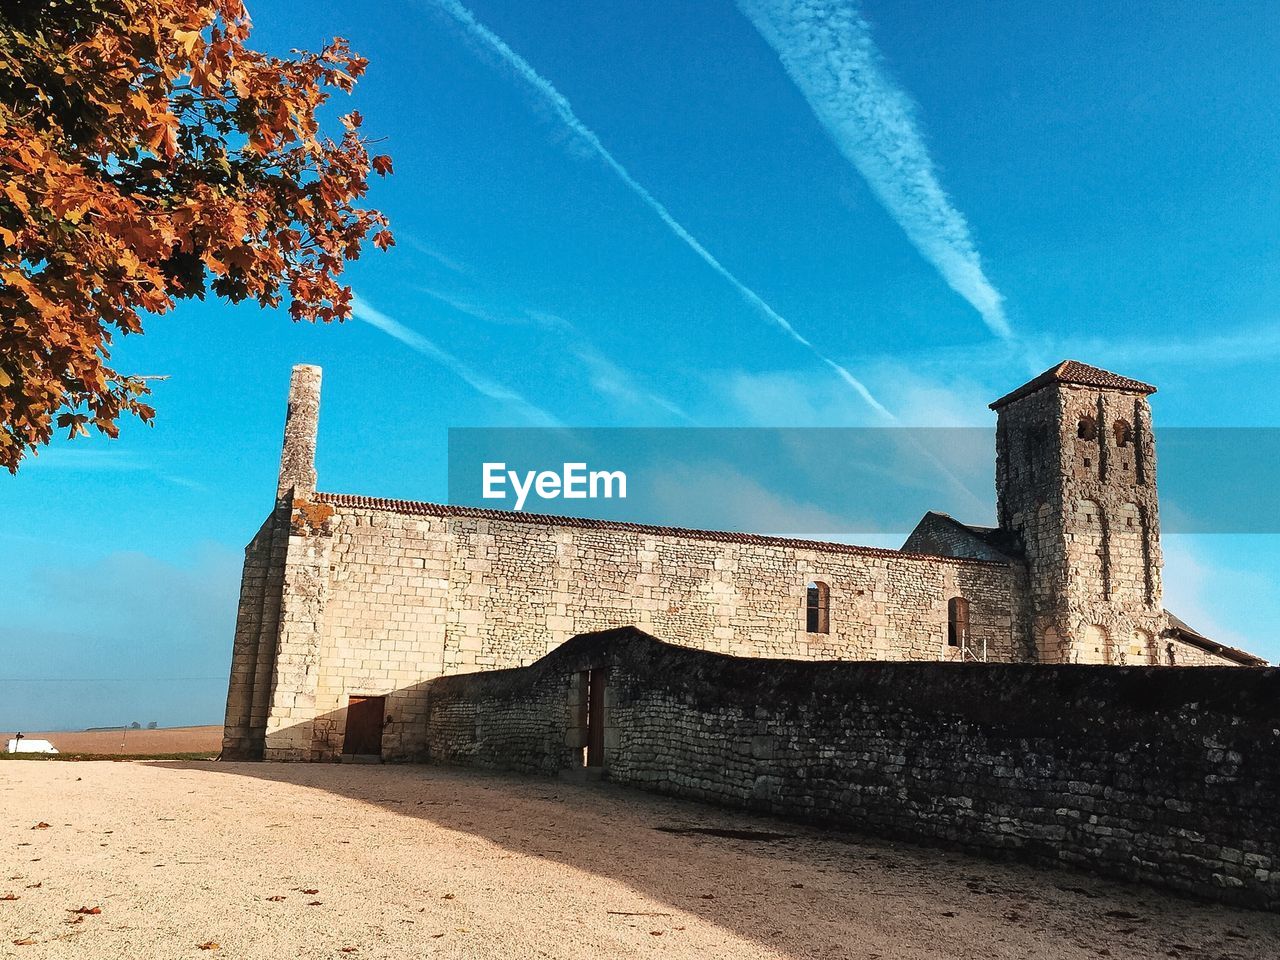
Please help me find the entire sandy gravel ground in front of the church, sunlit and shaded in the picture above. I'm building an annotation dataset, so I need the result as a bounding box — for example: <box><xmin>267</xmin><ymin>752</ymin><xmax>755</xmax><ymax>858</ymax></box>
<box><xmin>0</xmin><ymin>762</ymin><xmax>1280</xmax><ymax>960</ymax></box>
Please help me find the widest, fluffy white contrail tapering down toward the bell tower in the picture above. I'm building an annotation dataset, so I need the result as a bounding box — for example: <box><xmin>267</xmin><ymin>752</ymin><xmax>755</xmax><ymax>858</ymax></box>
<box><xmin>737</xmin><ymin>0</ymin><xmax>1014</xmax><ymax>339</ymax></box>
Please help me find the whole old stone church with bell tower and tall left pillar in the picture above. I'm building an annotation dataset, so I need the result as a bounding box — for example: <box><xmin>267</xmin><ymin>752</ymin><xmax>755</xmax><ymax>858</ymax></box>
<box><xmin>223</xmin><ymin>360</ymin><xmax>1265</xmax><ymax>760</ymax></box>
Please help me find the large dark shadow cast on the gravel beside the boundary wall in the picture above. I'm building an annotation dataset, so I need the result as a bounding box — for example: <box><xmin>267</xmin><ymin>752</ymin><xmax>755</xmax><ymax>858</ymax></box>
<box><xmin>155</xmin><ymin>763</ymin><xmax>1280</xmax><ymax>960</ymax></box>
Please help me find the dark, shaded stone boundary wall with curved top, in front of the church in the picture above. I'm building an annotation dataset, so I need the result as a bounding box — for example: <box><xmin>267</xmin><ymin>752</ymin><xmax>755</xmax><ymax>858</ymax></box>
<box><xmin>424</xmin><ymin>630</ymin><xmax>1280</xmax><ymax>910</ymax></box>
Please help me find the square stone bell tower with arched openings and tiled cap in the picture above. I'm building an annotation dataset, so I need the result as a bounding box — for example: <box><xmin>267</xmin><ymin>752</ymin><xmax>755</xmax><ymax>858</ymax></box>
<box><xmin>991</xmin><ymin>360</ymin><xmax>1166</xmax><ymax>664</ymax></box>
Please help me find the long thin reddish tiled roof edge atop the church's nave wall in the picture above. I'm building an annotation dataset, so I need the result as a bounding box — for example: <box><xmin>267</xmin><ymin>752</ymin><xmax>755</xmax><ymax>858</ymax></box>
<box><xmin>315</xmin><ymin>493</ymin><xmax>1005</xmax><ymax>566</ymax></box>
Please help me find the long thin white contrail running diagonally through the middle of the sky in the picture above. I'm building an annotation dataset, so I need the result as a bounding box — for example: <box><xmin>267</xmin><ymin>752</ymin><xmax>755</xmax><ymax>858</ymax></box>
<box><xmin>430</xmin><ymin>0</ymin><xmax>896</xmax><ymax>421</ymax></box>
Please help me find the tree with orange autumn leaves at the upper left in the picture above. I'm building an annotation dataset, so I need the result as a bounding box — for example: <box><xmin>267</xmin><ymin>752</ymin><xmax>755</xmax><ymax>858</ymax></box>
<box><xmin>0</xmin><ymin>0</ymin><xmax>392</xmax><ymax>471</ymax></box>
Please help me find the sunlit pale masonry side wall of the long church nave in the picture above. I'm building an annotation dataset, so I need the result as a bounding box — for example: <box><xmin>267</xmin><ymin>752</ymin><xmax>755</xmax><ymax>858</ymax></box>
<box><xmin>293</xmin><ymin>494</ymin><xmax>1015</xmax><ymax>759</ymax></box>
